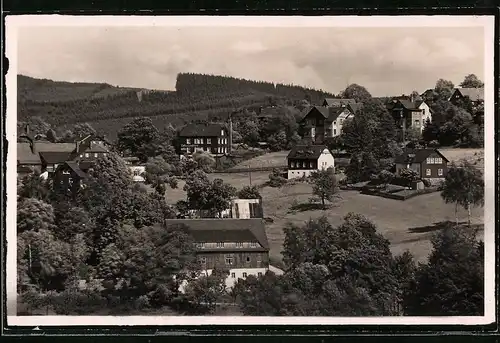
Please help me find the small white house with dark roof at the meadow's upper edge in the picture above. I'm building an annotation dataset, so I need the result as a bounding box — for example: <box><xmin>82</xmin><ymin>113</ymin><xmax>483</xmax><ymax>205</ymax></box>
<box><xmin>287</xmin><ymin>145</ymin><xmax>335</xmax><ymax>179</ymax></box>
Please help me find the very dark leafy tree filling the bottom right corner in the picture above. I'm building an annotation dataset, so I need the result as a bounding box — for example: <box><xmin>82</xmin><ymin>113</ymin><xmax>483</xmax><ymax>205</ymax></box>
<box><xmin>405</xmin><ymin>225</ymin><xmax>484</xmax><ymax>316</ymax></box>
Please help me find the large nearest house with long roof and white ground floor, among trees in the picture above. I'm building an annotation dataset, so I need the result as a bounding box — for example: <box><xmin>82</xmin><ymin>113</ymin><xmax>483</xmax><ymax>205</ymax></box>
<box><xmin>165</xmin><ymin>219</ymin><xmax>270</xmax><ymax>288</ymax></box>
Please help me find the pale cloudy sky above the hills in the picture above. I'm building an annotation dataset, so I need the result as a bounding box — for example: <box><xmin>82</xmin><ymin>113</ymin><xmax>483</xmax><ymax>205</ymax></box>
<box><xmin>18</xmin><ymin>26</ymin><xmax>484</xmax><ymax>96</ymax></box>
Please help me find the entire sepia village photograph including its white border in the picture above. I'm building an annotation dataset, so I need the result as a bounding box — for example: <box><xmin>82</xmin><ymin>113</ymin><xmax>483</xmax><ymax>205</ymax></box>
<box><xmin>5</xmin><ymin>15</ymin><xmax>498</xmax><ymax>325</ymax></box>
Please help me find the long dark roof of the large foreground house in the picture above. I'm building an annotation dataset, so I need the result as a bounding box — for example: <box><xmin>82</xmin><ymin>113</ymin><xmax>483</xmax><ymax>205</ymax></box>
<box><xmin>166</xmin><ymin>219</ymin><xmax>269</xmax><ymax>250</ymax></box>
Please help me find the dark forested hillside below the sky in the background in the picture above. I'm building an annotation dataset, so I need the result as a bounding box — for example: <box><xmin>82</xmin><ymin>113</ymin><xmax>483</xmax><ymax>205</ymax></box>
<box><xmin>18</xmin><ymin>74</ymin><xmax>333</xmax><ymax>138</ymax></box>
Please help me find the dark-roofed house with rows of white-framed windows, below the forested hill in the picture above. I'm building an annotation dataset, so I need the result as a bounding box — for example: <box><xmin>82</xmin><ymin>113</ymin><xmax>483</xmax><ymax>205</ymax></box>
<box><xmin>177</xmin><ymin>123</ymin><xmax>231</xmax><ymax>156</ymax></box>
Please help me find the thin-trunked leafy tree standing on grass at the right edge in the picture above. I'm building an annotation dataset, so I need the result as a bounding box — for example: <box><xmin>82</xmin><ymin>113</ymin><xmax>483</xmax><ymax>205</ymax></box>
<box><xmin>441</xmin><ymin>160</ymin><xmax>484</xmax><ymax>226</ymax></box>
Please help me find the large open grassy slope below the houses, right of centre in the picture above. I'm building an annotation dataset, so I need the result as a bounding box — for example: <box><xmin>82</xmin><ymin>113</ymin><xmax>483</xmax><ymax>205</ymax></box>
<box><xmin>261</xmin><ymin>183</ymin><xmax>484</xmax><ymax>261</ymax></box>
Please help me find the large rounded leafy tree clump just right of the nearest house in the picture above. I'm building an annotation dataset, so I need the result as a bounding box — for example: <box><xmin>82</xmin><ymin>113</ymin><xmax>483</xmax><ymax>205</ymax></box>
<box><xmin>234</xmin><ymin>213</ymin><xmax>412</xmax><ymax>316</ymax></box>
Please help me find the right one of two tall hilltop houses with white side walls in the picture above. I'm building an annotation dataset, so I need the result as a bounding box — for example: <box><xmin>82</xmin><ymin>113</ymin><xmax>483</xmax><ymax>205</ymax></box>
<box><xmin>387</xmin><ymin>99</ymin><xmax>432</xmax><ymax>132</ymax></box>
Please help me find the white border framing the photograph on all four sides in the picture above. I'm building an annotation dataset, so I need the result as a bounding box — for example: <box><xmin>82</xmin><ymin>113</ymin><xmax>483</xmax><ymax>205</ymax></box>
<box><xmin>5</xmin><ymin>15</ymin><xmax>497</xmax><ymax>327</ymax></box>
